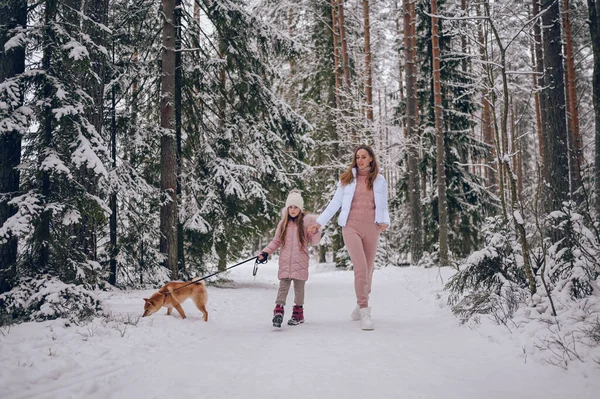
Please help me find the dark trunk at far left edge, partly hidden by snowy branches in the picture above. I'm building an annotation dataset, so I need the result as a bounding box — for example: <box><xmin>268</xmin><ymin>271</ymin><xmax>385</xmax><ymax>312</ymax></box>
<box><xmin>0</xmin><ymin>0</ymin><xmax>27</xmax><ymax>294</ymax></box>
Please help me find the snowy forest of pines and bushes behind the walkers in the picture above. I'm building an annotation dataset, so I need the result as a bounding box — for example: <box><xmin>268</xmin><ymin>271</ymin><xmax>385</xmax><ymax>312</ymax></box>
<box><xmin>0</xmin><ymin>0</ymin><xmax>600</xmax><ymax>356</ymax></box>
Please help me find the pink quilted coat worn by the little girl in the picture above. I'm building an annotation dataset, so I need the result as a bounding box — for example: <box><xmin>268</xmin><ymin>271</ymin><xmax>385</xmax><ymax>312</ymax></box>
<box><xmin>261</xmin><ymin>210</ymin><xmax>321</xmax><ymax>280</ymax></box>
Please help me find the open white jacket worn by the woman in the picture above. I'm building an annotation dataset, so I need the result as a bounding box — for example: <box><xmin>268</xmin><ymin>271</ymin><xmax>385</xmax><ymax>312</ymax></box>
<box><xmin>317</xmin><ymin>168</ymin><xmax>390</xmax><ymax>227</ymax></box>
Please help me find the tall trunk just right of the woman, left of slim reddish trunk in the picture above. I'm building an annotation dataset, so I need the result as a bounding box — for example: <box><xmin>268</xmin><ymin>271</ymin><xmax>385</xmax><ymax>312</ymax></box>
<box><xmin>404</xmin><ymin>0</ymin><xmax>423</xmax><ymax>264</ymax></box>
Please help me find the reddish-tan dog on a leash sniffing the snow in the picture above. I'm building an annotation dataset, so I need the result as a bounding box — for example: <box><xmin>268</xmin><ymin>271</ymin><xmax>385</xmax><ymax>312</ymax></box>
<box><xmin>142</xmin><ymin>277</ymin><xmax>208</xmax><ymax>321</ymax></box>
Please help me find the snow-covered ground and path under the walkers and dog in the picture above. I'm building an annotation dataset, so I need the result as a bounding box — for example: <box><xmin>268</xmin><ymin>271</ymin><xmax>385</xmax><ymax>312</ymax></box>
<box><xmin>0</xmin><ymin>260</ymin><xmax>600</xmax><ymax>399</ymax></box>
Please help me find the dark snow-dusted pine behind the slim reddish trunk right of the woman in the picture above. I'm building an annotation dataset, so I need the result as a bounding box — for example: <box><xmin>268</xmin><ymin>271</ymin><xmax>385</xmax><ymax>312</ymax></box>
<box><xmin>417</xmin><ymin>2</ymin><xmax>497</xmax><ymax>256</ymax></box>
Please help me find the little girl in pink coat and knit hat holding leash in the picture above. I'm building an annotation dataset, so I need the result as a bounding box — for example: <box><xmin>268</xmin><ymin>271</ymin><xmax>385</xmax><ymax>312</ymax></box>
<box><xmin>258</xmin><ymin>189</ymin><xmax>321</xmax><ymax>327</ymax></box>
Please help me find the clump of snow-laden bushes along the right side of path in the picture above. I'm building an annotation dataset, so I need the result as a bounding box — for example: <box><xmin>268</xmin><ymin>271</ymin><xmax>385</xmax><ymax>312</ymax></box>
<box><xmin>446</xmin><ymin>203</ymin><xmax>600</xmax><ymax>368</ymax></box>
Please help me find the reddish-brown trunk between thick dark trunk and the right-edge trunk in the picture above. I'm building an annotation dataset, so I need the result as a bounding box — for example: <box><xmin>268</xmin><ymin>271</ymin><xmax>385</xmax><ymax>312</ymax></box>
<box><xmin>562</xmin><ymin>0</ymin><xmax>583</xmax><ymax>202</ymax></box>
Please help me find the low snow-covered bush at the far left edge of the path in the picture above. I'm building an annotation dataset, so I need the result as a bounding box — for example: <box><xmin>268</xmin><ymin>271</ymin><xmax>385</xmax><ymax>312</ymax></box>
<box><xmin>0</xmin><ymin>275</ymin><xmax>103</xmax><ymax>324</ymax></box>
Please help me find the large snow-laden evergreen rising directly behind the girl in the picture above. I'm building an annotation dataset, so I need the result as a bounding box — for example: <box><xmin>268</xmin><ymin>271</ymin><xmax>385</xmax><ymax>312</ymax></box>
<box><xmin>181</xmin><ymin>1</ymin><xmax>308</xmax><ymax>269</ymax></box>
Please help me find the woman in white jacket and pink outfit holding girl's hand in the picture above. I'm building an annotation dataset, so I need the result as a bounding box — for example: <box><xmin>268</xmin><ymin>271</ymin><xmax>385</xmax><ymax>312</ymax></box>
<box><xmin>310</xmin><ymin>145</ymin><xmax>390</xmax><ymax>330</ymax></box>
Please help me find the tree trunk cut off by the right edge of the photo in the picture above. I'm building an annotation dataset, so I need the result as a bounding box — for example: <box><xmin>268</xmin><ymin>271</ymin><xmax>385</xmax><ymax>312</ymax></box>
<box><xmin>588</xmin><ymin>0</ymin><xmax>600</xmax><ymax>220</ymax></box>
